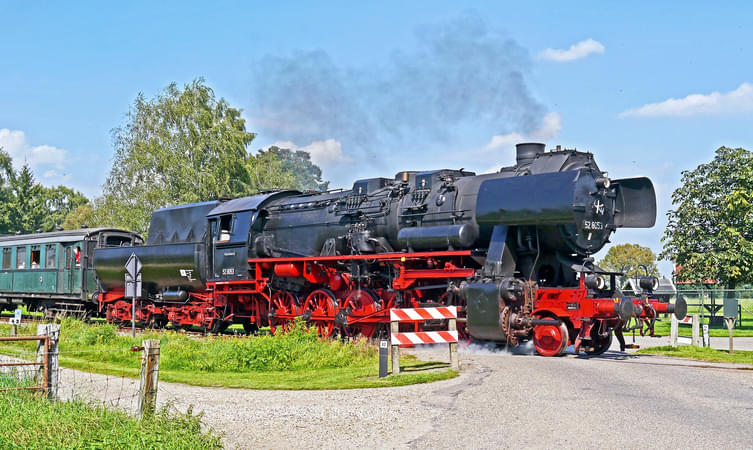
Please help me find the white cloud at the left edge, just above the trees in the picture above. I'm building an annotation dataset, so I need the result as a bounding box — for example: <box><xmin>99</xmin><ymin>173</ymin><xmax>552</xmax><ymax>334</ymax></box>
<box><xmin>0</xmin><ymin>128</ymin><xmax>68</xmax><ymax>176</ymax></box>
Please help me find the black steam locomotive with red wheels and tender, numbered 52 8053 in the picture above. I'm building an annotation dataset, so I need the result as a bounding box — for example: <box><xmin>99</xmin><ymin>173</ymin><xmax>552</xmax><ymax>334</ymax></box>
<box><xmin>94</xmin><ymin>143</ymin><xmax>686</xmax><ymax>356</ymax></box>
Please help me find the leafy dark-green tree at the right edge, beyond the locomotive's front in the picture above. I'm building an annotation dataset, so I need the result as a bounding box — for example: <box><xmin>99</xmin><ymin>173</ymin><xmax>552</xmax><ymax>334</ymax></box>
<box><xmin>660</xmin><ymin>147</ymin><xmax>753</xmax><ymax>289</ymax></box>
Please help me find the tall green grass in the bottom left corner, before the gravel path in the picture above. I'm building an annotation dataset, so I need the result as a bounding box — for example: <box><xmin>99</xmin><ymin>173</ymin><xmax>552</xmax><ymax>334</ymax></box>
<box><xmin>0</xmin><ymin>377</ymin><xmax>222</xmax><ymax>449</ymax></box>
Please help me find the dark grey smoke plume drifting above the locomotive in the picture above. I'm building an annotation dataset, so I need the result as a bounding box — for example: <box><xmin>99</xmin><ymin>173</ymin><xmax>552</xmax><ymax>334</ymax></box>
<box><xmin>247</xmin><ymin>17</ymin><xmax>546</xmax><ymax>180</ymax></box>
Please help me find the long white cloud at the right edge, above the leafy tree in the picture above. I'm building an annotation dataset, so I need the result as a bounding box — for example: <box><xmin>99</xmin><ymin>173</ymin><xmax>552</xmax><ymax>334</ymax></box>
<box><xmin>619</xmin><ymin>83</ymin><xmax>753</xmax><ymax>117</ymax></box>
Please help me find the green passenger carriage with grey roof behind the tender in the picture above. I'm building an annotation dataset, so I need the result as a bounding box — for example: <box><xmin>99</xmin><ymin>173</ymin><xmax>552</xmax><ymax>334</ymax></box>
<box><xmin>0</xmin><ymin>228</ymin><xmax>143</xmax><ymax>317</ymax></box>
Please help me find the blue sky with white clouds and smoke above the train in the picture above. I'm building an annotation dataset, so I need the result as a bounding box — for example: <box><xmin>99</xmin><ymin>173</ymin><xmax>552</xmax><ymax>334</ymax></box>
<box><xmin>0</xmin><ymin>1</ymin><xmax>753</xmax><ymax>273</ymax></box>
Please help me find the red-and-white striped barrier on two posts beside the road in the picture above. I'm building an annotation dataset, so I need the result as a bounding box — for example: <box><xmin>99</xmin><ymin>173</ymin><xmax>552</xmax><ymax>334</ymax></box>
<box><xmin>390</xmin><ymin>306</ymin><xmax>460</xmax><ymax>375</ymax></box>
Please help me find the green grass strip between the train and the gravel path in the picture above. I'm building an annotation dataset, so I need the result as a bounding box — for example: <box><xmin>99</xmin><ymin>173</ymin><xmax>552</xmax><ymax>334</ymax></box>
<box><xmin>0</xmin><ymin>319</ymin><xmax>457</xmax><ymax>389</ymax></box>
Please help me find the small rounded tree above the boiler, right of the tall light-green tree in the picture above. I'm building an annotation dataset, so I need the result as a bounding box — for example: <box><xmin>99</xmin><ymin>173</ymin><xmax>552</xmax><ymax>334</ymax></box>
<box><xmin>248</xmin><ymin>146</ymin><xmax>329</xmax><ymax>191</ymax></box>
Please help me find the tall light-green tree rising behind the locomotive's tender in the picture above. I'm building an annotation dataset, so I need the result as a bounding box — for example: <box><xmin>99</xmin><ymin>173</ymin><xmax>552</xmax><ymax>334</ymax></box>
<box><xmin>97</xmin><ymin>79</ymin><xmax>254</xmax><ymax>233</ymax></box>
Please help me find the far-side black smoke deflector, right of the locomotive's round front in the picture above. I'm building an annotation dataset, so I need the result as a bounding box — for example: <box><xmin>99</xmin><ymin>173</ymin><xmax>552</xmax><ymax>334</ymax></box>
<box><xmin>612</xmin><ymin>177</ymin><xmax>656</xmax><ymax>228</ymax></box>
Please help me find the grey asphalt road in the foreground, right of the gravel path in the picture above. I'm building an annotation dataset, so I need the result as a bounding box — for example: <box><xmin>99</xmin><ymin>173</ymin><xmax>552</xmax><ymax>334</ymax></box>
<box><xmin>405</xmin><ymin>351</ymin><xmax>753</xmax><ymax>448</ymax></box>
